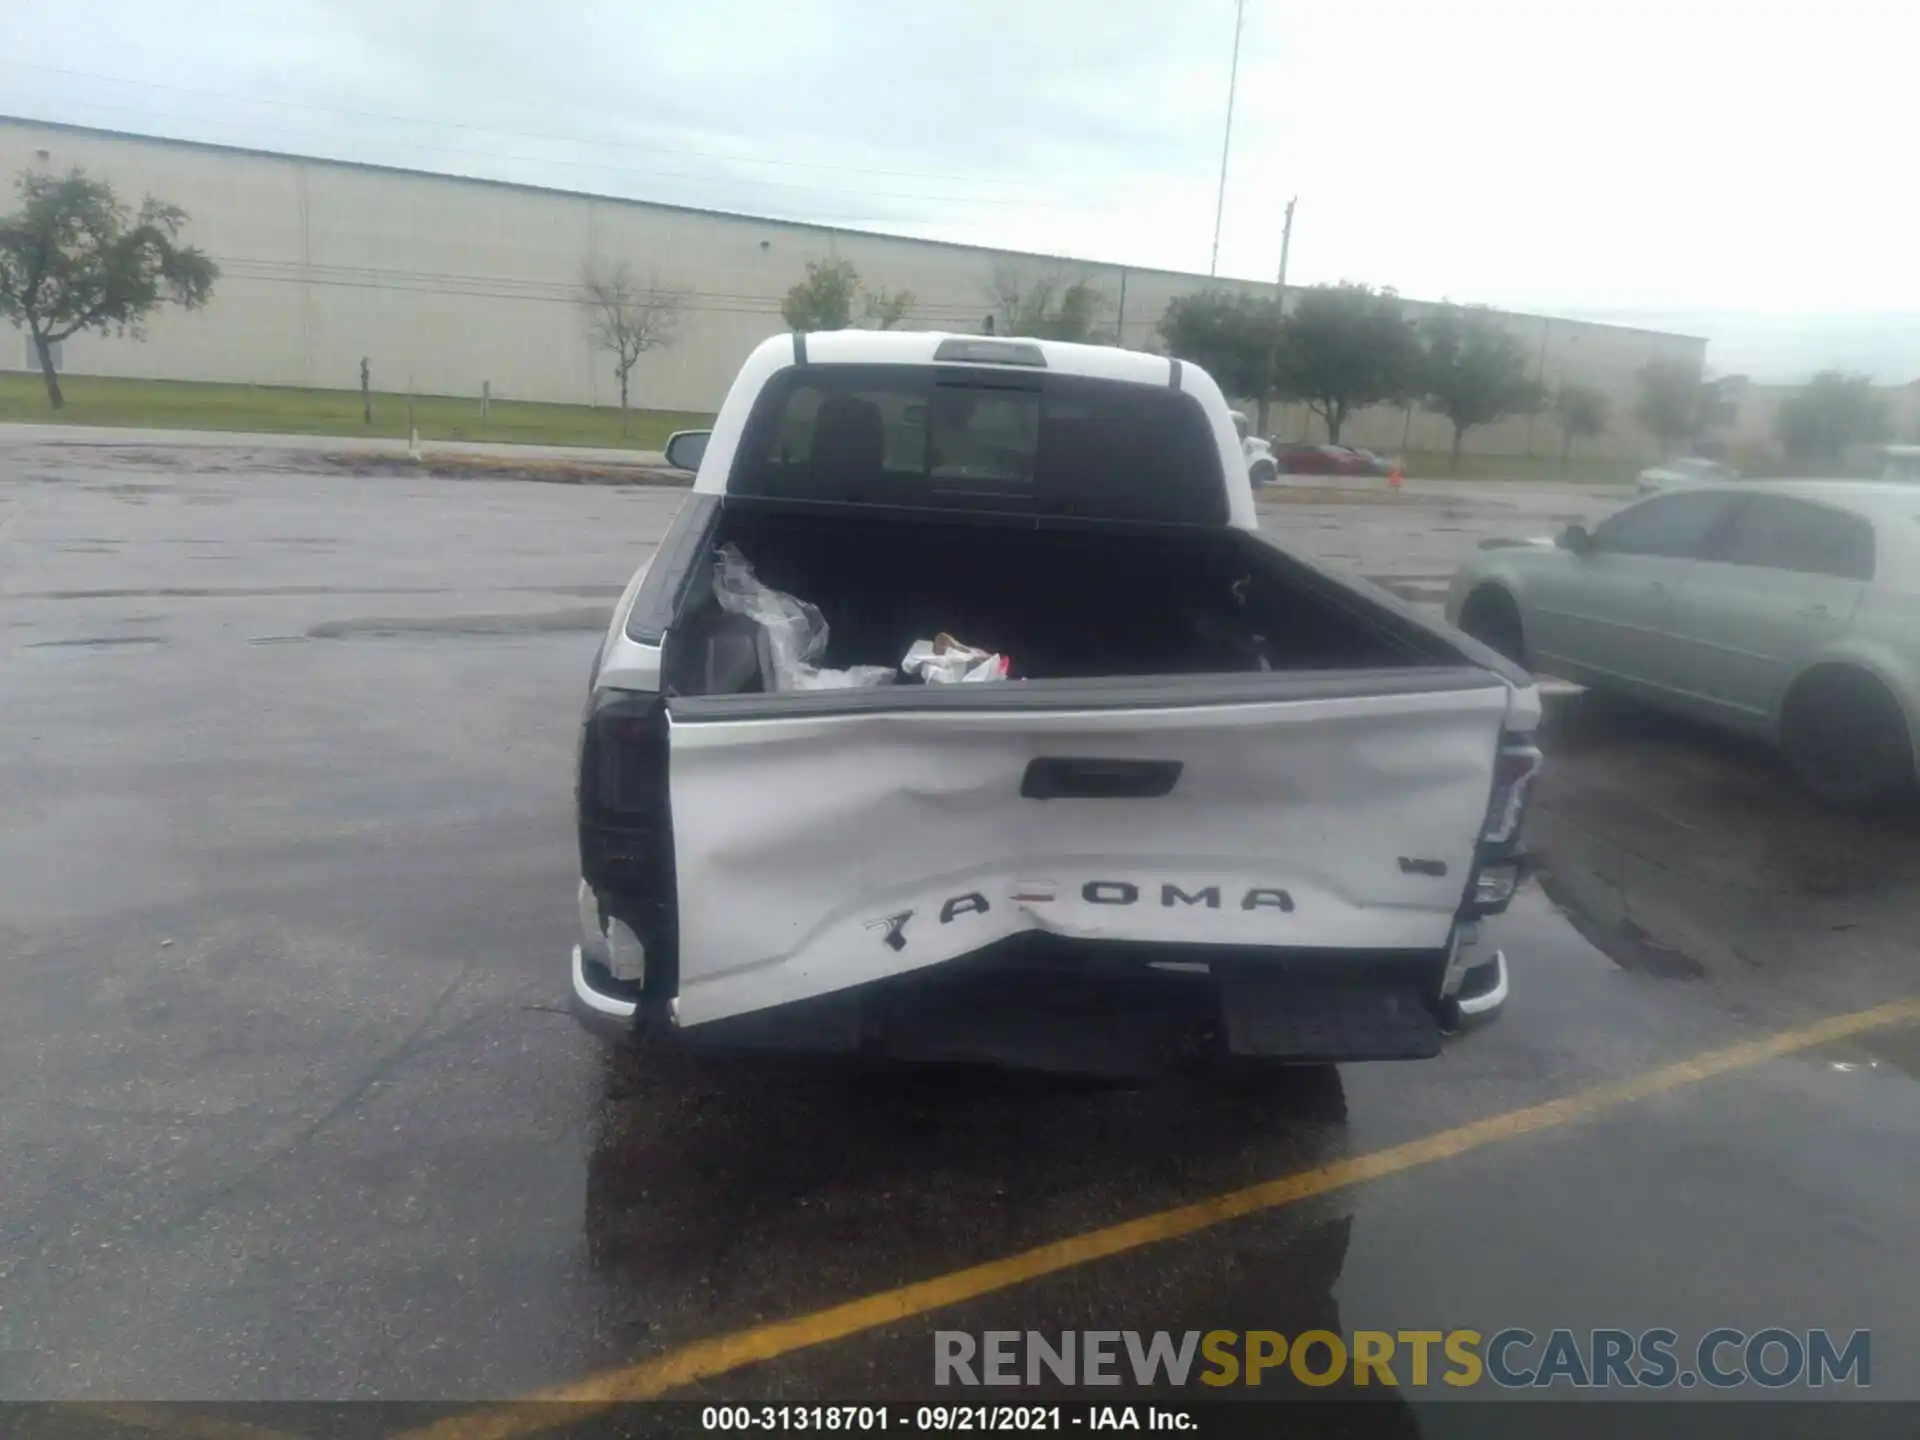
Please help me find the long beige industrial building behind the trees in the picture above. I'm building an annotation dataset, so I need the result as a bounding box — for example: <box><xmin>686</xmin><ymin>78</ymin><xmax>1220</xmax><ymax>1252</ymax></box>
<box><xmin>0</xmin><ymin>119</ymin><xmax>1707</xmax><ymax>455</ymax></box>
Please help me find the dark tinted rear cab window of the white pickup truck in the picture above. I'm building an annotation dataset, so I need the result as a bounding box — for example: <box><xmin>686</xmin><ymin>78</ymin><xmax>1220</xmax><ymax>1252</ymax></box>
<box><xmin>728</xmin><ymin>365</ymin><xmax>1227</xmax><ymax>526</ymax></box>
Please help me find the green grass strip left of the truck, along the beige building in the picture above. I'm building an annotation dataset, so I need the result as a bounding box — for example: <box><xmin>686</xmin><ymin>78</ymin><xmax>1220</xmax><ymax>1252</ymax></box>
<box><xmin>0</xmin><ymin>372</ymin><xmax>712</xmax><ymax>449</ymax></box>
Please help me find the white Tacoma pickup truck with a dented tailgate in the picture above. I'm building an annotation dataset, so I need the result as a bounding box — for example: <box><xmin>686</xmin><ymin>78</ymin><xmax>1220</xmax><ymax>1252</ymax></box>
<box><xmin>572</xmin><ymin>330</ymin><xmax>1540</xmax><ymax>1071</ymax></box>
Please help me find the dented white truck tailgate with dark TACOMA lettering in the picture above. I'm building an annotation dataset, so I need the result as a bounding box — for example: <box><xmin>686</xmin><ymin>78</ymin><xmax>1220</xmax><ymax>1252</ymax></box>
<box><xmin>670</xmin><ymin>684</ymin><xmax>1511</xmax><ymax>1025</ymax></box>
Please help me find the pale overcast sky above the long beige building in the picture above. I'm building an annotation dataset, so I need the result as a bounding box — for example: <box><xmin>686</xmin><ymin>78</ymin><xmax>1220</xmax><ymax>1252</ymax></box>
<box><xmin>0</xmin><ymin>0</ymin><xmax>1920</xmax><ymax>382</ymax></box>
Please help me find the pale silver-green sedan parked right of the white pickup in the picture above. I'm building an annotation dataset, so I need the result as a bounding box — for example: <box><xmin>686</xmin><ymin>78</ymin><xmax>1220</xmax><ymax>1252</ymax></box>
<box><xmin>1448</xmin><ymin>480</ymin><xmax>1920</xmax><ymax>804</ymax></box>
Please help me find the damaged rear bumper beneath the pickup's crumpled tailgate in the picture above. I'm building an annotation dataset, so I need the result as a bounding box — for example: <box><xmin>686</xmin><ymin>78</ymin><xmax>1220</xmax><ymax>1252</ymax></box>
<box><xmin>570</xmin><ymin>929</ymin><xmax>1509</xmax><ymax>1075</ymax></box>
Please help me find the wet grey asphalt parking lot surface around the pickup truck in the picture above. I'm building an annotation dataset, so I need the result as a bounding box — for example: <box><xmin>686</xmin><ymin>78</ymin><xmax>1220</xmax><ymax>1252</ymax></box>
<box><xmin>0</xmin><ymin>440</ymin><xmax>1920</xmax><ymax>1434</ymax></box>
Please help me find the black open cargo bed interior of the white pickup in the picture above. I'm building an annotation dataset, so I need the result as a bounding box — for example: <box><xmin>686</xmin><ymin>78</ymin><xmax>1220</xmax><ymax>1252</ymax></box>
<box><xmin>666</xmin><ymin>505</ymin><xmax>1461</xmax><ymax>695</ymax></box>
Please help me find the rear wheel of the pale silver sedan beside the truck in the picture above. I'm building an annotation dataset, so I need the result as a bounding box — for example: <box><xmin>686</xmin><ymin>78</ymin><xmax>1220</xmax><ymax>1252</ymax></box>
<box><xmin>1780</xmin><ymin>666</ymin><xmax>1914</xmax><ymax>808</ymax></box>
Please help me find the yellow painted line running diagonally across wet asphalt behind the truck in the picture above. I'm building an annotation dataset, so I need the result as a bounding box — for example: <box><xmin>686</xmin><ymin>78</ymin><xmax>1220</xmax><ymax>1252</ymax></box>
<box><xmin>405</xmin><ymin>998</ymin><xmax>1920</xmax><ymax>1440</ymax></box>
